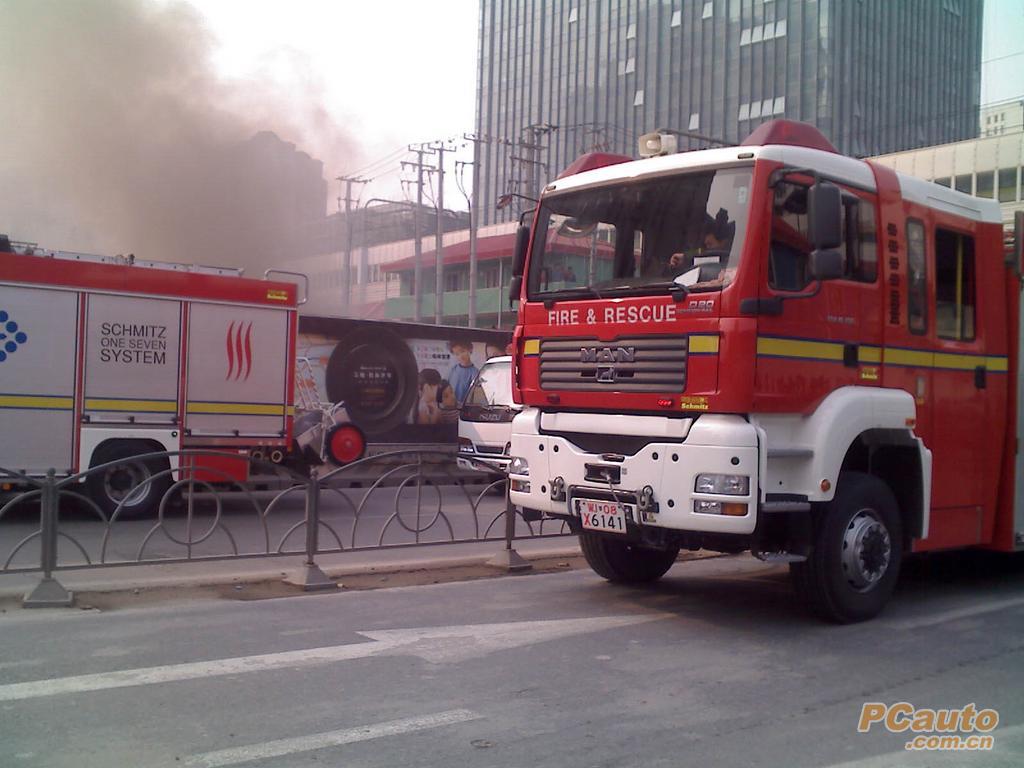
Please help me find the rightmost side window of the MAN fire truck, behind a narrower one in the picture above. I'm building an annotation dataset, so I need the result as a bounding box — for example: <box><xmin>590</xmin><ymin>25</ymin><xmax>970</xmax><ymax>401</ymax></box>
<box><xmin>935</xmin><ymin>229</ymin><xmax>975</xmax><ymax>341</ymax></box>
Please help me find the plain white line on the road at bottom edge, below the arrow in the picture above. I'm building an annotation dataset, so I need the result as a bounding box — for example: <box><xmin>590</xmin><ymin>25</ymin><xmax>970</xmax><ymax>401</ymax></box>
<box><xmin>183</xmin><ymin>710</ymin><xmax>481</xmax><ymax>768</ymax></box>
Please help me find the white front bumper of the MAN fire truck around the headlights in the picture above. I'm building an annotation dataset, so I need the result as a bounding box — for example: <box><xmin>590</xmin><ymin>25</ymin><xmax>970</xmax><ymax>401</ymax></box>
<box><xmin>509</xmin><ymin>409</ymin><xmax>759</xmax><ymax>535</ymax></box>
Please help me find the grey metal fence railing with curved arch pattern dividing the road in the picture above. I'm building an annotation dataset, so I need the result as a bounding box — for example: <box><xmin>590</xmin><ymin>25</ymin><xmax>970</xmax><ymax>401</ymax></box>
<box><xmin>0</xmin><ymin>450</ymin><xmax>568</xmax><ymax>605</ymax></box>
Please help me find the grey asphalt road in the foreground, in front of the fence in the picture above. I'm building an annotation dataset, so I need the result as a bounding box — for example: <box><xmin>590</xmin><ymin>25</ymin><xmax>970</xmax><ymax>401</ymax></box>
<box><xmin>0</xmin><ymin>557</ymin><xmax>1024</xmax><ymax>768</ymax></box>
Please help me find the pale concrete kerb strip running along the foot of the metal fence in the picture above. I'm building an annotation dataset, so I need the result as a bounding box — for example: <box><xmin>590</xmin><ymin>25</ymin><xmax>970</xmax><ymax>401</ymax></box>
<box><xmin>0</xmin><ymin>536</ymin><xmax>581</xmax><ymax>601</ymax></box>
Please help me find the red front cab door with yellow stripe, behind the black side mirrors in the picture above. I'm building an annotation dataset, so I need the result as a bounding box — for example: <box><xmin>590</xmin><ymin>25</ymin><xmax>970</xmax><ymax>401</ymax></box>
<box><xmin>755</xmin><ymin>180</ymin><xmax>882</xmax><ymax>413</ymax></box>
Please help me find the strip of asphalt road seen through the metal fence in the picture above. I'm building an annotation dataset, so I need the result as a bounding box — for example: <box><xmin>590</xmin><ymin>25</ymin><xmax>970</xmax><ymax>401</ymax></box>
<box><xmin>0</xmin><ymin>484</ymin><xmax>560</xmax><ymax>568</ymax></box>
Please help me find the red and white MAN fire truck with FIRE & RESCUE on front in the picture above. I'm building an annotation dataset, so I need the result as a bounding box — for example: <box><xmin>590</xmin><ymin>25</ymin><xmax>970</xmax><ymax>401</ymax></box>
<box><xmin>510</xmin><ymin>121</ymin><xmax>1024</xmax><ymax>622</ymax></box>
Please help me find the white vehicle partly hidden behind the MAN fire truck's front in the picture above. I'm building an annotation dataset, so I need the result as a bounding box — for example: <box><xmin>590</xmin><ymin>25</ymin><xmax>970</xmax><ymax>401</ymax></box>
<box><xmin>458</xmin><ymin>356</ymin><xmax>522</xmax><ymax>473</ymax></box>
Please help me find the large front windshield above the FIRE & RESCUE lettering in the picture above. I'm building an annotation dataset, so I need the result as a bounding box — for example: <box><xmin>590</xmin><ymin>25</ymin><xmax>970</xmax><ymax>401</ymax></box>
<box><xmin>527</xmin><ymin>168</ymin><xmax>751</xmax><ymax>299</ymax></box>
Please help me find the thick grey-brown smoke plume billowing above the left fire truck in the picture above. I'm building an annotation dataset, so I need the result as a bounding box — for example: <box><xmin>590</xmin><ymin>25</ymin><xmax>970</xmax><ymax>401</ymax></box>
<box><xmin>0</xmin><ymin>0</ymin><xmax>351</xmax><ymax>268</ymax></box>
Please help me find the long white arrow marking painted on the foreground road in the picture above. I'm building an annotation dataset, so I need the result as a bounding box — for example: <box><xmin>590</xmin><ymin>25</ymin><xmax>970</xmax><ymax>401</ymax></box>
<box><xmin>0</xmin><ymin>613</ymin><xmax>666</xmax><ymax>701</ymax></box>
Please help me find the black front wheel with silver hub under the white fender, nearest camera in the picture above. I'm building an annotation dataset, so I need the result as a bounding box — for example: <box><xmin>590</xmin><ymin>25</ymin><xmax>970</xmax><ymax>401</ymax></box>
<box><xmin>790</xmin><ymin>472</ymin><xmax>903</xmax><ymax>624</ymax></box>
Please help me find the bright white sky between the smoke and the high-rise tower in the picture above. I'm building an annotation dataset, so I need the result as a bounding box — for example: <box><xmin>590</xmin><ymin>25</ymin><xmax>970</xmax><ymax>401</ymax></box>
<box><xmin>187</xmin><ymin>0</ymin><xmax>479</xmax><ymax>210</ymax></box>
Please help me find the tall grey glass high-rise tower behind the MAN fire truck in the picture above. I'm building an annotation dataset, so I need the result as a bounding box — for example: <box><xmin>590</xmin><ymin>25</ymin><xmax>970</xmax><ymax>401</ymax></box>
<box><xmin>476</xmin><ymin>0</ymin><xmax>983</xmax><ymax>222</ymax></box>
